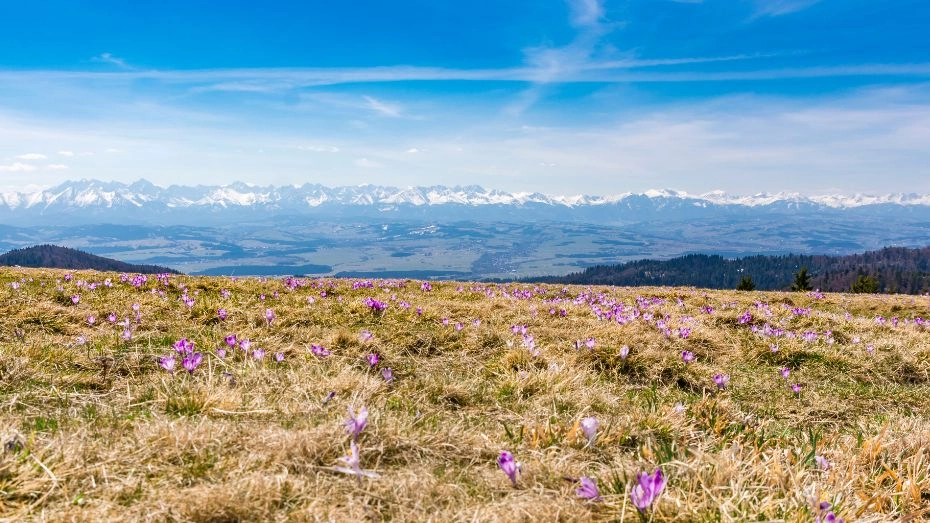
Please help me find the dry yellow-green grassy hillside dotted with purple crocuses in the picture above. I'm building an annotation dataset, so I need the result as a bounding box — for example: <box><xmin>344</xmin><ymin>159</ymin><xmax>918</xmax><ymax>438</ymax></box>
<box><xmin>0</xmin><ymin>269</ymin><xmax>930</xmax><ymax>522</ymax></box>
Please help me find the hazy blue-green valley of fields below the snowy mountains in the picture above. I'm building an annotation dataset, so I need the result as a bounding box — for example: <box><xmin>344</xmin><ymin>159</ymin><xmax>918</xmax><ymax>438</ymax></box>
<box><xmin>0</xmin><ymin>214</ymin><xmax>930</xmax><ymax>280</ymax></box>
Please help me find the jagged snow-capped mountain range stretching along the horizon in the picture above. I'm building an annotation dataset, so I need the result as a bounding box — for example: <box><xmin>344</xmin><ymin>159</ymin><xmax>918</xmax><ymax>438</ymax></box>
<box><xmin>0</xmin><ymin>180</ymin><xmax>930</xmax><ymax>216</ymax></box>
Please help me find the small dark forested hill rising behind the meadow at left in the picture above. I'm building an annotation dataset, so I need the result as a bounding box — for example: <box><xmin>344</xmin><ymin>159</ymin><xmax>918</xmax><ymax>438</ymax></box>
<box><xmin>0</xmin><ymin>245</ymin><xmax>178</xmax><ymax>274</ymax></box>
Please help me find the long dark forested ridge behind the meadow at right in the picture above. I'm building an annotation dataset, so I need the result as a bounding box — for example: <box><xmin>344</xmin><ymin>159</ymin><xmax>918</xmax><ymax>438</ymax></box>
<box><xmin>532</xmin><ymin>247</ymin><xmax>930</xmax><ymax>294</ymax></box>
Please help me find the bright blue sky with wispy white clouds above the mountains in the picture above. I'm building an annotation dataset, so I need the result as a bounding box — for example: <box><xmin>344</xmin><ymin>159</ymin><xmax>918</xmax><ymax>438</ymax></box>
<box><xmin>0</xmin><ymin>0</ymin><xmax>930</xmax><ymax>195</ymax></box>
